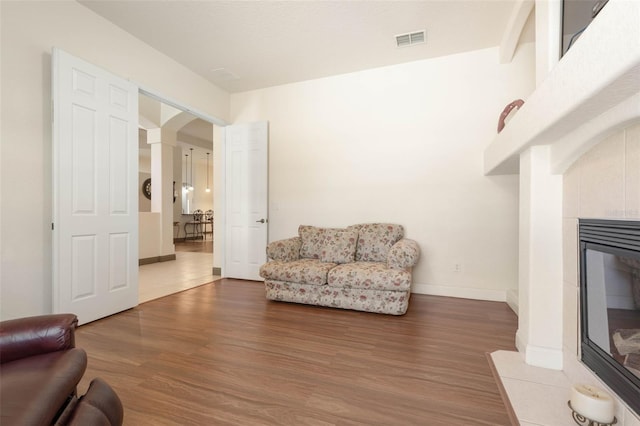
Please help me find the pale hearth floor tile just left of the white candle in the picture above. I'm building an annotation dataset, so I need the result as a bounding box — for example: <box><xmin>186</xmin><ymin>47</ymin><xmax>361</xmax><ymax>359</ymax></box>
<box><xmin>502</xmin><ymin>378</ymin><xmax>575</xmax><ymax>426</ymax></box>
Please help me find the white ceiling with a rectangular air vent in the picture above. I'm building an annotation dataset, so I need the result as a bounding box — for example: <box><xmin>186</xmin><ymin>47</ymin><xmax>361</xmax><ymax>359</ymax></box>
<box><xmin>78</xmin><ymin>0</ymin><xmax>533</xmax><ymax>93</ymax></box>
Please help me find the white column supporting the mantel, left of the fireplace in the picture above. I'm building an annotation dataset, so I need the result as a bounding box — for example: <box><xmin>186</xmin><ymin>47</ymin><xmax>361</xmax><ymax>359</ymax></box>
<box><xmin>516</xmin><ymin>146</ymin><xmax>563</xmax><ymax>370</ymax></box>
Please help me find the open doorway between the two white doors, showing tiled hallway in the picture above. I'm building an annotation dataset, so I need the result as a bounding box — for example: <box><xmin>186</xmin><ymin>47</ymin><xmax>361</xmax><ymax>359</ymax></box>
<box><xmin>138</xmin><ymin>91</ymin><xmax>220</xmax><ymax>303</ymax></box>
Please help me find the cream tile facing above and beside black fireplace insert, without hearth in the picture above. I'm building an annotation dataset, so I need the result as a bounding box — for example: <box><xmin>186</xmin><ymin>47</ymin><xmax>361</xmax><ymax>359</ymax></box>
<box><xmin>562</xmin><ymin>124</ymin><xmax>640</xmax><ymax>425</ymax></box>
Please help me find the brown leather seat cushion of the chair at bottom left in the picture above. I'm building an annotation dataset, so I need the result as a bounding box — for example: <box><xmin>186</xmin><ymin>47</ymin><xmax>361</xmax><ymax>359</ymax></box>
<box><xmin>0</xmin><ymin>348</ymin><xmax>87</xmax><ymax>425</ymax></box>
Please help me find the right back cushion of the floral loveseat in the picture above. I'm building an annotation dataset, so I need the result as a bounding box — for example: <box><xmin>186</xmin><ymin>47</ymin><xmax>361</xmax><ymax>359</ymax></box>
<box><xmin>347</xmin><ymin>223</ymin><xmax>404</xmax><ymax>262</ymax></box>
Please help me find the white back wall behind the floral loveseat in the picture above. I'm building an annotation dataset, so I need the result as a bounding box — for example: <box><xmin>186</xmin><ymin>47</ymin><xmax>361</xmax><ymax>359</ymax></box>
<box><xmin>231</xmin><ymin>45</ymin><xmax>535</xmax><ymax>300</ymax></box>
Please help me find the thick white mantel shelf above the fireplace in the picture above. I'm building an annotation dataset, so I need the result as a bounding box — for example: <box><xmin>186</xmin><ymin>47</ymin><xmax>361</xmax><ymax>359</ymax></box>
<box><xmin>484</xmin><ymin>0</ymin><xmax>640</xmax><ymax>175</ymax></box>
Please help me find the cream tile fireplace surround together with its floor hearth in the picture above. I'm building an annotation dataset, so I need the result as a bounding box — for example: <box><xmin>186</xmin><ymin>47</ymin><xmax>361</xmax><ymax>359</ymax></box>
<box><xmin>492</xmin><ymin>125</ymin><xmax>640</xmax><ymax>426</ymax></box>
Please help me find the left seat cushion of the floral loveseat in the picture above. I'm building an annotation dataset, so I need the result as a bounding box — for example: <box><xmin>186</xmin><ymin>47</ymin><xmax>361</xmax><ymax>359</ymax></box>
<box><xmin>260</xmin><ymin>259</ymin><xmax>336</xmax><ymax>285</ymax></box>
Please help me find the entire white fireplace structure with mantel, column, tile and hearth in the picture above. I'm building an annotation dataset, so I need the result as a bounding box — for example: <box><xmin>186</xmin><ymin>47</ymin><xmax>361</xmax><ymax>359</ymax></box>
<box><xmin>485</xmin><ymin>0</ymin><xmax>640</xmax><ymax>426</ymax></box>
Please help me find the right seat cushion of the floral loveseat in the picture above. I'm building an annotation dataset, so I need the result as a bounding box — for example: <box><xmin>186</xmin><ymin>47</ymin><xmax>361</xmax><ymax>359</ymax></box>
<box><xmin>327</xmin><ymin>262</ymin><xmax>411</xmax><ymax>291</ymax></box>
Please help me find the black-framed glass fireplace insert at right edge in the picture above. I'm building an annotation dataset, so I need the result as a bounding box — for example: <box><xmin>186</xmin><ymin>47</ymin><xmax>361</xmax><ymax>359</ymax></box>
<box><xmin>578</xmin><ymin>219</ymin><xmax>640</xmax><ymax>413</ymax></box>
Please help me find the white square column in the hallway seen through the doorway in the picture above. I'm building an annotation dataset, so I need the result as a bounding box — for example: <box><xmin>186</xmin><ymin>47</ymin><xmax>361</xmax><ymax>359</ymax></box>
<box><xmin>147</xmin><ymin>129</ymin><xmax>175</xmax><ymax>256</ymax></box>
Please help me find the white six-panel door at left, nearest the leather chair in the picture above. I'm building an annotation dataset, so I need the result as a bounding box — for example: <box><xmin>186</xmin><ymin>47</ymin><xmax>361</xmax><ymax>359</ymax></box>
<box><xmin>52</xmin><ymin>49</ymin><xmax>138</xmax><ymax>323</ymax></box>
